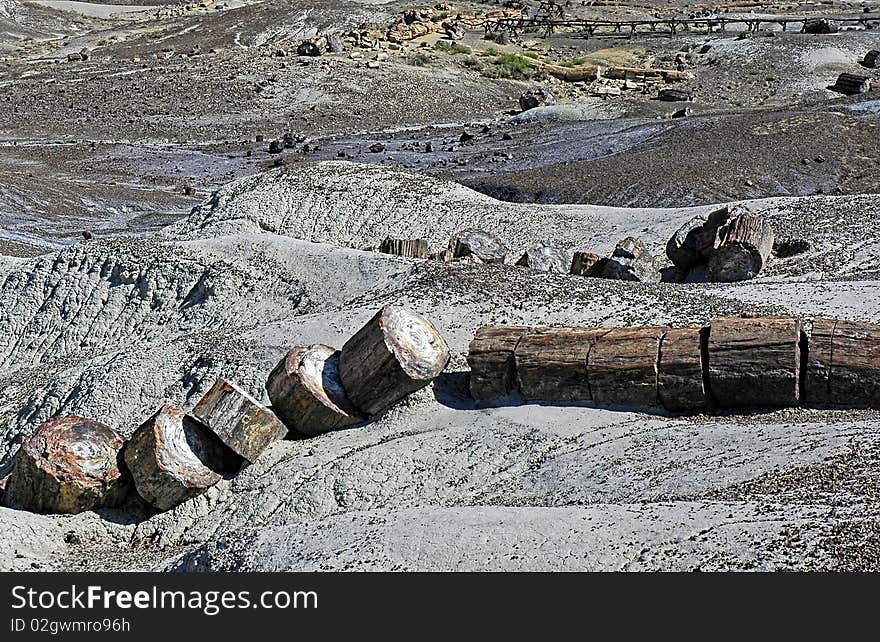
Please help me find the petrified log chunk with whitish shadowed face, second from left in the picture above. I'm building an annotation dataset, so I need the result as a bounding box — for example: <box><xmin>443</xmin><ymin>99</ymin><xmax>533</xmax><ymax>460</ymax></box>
<box><xmin>123</xmin><ymin>404</ymin><xmax>244</xmax><ymax>510</ymax></box>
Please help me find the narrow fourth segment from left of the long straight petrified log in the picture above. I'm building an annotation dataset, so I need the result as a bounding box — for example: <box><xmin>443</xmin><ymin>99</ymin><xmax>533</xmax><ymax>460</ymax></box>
<box><xmin>657</xmin><ymin>328</ymin><xmax>709</xmax><ymax>413</ymax></box>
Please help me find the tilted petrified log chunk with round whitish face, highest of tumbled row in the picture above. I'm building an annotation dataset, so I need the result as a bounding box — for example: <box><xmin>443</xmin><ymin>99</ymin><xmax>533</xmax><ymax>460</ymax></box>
<box><xmin>339</xmin><ymin>305</ymin><xmax>449</xmax><ymax>416</ymax></box>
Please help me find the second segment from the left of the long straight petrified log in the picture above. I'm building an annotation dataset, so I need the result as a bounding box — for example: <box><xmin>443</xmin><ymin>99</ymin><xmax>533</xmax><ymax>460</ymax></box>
<box><xmin>514</xmin><ymin>328</ymin><xmax>608</xmax><ymax>403</ymax></box>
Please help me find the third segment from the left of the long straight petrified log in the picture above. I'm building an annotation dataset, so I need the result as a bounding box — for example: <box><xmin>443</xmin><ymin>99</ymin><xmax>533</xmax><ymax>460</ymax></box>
<box><xmin>587</xmin><ymin>327</ymin><xmax>666</xmax><ymax>408</ymax></box>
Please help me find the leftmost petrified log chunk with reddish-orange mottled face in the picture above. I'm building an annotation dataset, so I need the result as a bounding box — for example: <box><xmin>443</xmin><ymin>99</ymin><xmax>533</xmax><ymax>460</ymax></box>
<box><xmin>3</xmin><ymin>416</ymin><xmax>130</xmax><ymax>513</ymax></box>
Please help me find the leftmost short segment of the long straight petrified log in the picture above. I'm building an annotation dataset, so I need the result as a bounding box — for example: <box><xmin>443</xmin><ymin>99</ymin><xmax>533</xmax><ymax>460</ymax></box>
<box><xmin>467</xmin><ymin>326</ymin><xmax>529</xmax><ymax>401</ymax></box>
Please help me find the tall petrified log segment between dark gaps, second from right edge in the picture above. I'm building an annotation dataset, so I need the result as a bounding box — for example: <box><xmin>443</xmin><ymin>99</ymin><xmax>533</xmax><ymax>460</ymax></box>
<box><xmin>708</xmin><ymin>317</ymin><xmax>801</xmax><ymax>408</ymax></box>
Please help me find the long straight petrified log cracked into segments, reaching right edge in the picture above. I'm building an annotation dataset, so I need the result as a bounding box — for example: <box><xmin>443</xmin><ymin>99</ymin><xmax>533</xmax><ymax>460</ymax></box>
<box><xmin>468</xmin><ymin>317</ymin><xmax>880</xmax><ymax>414</ymax></box>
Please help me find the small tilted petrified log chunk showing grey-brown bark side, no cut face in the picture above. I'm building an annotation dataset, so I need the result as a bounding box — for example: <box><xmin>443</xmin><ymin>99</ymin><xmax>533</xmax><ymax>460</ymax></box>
<box><xmin>193</xmin><ymin>379</ymin><xmax>287</xmax><ymax>463</ymax></box>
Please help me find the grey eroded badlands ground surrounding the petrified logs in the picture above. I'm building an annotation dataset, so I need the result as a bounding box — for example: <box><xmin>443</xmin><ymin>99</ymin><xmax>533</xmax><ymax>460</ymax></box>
<box><xmin>0</xmin><ymin>0</ymin><xmax>880</xmax><ymax>571</ymax></box>
